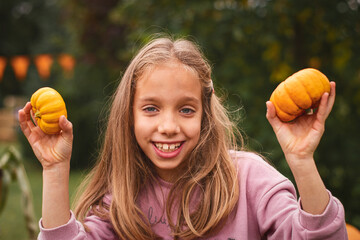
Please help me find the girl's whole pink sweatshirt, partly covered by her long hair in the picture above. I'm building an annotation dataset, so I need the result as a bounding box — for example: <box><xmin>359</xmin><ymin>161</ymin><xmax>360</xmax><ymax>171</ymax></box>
<box><xmin>39</xmin><ymin>152</ymin><xmax>347</xmax><ymax>240</ymax></box>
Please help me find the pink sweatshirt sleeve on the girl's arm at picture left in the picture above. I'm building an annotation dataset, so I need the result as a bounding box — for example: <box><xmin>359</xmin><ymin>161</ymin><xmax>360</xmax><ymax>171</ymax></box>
<box><xmin>38</xmin><ymin>212</ymin><xmax>116</xmax><ymax>240</ymax></box>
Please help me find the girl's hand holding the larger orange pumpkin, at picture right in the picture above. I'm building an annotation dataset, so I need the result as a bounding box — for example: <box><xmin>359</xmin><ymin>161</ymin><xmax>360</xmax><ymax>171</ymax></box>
<box><xmin>266</xmin><ymin>82</ymin><xmax>335</xmax><ymax>163</ymax></box>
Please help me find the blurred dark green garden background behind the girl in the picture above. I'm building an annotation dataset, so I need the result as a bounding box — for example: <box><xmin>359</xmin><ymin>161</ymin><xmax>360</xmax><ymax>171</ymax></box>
<box><xmin>0</xmin><ymin>0</ymin><xmax>360</xmax><ymax>240</ymax></box>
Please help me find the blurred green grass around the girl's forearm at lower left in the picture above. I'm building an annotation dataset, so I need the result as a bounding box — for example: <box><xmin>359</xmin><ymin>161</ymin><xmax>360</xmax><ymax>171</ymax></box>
<box><xmin>0</xmin><ymin>158</ymin><xmax>83</xmax><ymax>240</ymax></box>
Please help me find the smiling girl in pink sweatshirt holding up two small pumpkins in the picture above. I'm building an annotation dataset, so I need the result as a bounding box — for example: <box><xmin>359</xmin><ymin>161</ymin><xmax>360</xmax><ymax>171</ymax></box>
<box><xmin>19</xmin><ymin>38</ymin><xmax>347</xmax><ymax>240</ymax></box>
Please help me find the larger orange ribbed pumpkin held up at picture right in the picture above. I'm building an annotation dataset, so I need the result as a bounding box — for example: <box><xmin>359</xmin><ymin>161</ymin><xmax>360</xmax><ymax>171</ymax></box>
<box><xmin>270</xmin><ymin>68</ymin><xmax>330</xmax><ymax>122</ymax></box>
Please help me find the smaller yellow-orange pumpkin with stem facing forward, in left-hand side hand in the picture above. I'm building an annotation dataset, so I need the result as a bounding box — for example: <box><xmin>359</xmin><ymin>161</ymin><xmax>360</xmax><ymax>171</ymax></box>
<box><xmin>30</xmin><ymin>87</ymin><xmax>67</xmax><ymax>134</ymax></box>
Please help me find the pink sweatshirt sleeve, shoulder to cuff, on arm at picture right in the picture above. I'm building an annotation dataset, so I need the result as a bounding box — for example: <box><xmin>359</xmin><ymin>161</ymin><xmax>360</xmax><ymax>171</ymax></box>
<box><xmin>237</xmin><ymin>152</ymin><xmax>347</xmax><ymax>240</ymax></box>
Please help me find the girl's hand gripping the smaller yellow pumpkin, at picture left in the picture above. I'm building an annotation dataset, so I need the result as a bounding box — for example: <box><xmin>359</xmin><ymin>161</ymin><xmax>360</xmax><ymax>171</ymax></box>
<box><xmin>19</xmin><ymin>102</ymin><xmax>73</xmax><ymax>170</ymax></box>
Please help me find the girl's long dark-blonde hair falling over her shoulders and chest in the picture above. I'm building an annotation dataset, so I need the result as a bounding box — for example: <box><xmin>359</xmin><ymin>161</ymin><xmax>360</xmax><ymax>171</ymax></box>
<box><xmin>75</xmin><ymin>38</ymin><xmax>239</xmax><ymax>239</ymax></box>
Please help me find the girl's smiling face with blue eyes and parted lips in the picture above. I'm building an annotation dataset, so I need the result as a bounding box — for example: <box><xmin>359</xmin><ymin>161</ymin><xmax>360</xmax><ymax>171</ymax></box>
<box><xmin>133</xmin><ymin>61</ymin><xmax>202</xmax><ymax>181</ymax></box>
